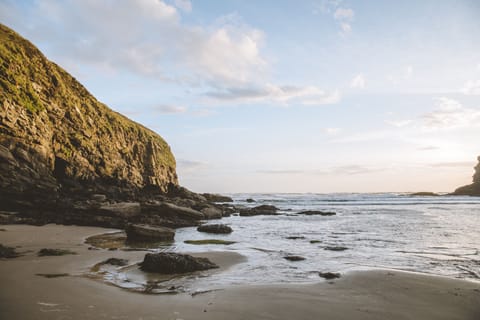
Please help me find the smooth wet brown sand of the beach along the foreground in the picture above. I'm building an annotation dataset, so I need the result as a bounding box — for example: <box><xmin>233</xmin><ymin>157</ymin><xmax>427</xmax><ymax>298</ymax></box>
<box><xmin>0</xmin><ymin>225</ymin><xmax>480</xmax><ymax>320</ymax></box>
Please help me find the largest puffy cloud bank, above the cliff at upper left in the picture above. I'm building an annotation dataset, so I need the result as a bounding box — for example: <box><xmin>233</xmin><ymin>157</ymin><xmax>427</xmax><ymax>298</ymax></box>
<box><xmin>0</xmin><ymin>0</ymin><xmax>268</xmax><ymax>84</ymax></box>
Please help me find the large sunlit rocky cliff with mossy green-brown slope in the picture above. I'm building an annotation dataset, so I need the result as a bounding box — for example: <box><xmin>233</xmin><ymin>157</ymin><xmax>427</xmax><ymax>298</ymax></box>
<box><xmin>0</xmin><ymin>25</ymin><xmax>178</xmax><ymax>210</ymax></box>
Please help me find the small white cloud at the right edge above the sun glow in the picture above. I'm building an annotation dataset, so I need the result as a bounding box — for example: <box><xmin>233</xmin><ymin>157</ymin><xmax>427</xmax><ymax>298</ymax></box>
<box><xmin>421</xmin><ymin>97</ymin><xmax>480</xmax><ymax>130</ymax></box>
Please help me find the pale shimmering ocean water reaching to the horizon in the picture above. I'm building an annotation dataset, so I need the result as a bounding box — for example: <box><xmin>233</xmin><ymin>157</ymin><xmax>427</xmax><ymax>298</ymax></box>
<box><xmin>117</xmin><ymin>193</ymin><xmax>480</xmax><ymax>290</ymax></box>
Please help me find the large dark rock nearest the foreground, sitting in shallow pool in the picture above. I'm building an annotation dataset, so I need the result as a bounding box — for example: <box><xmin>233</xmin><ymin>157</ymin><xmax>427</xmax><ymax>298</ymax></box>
<box><xmin>140</xmin><ymin>252</ymin><xmax>218</xmax><ymax>274</ymax></box>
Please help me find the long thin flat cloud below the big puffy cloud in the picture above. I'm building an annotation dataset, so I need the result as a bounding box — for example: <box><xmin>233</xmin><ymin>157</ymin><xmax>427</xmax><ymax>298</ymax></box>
<box><xmin>206</xmin><ymin>84</ymin><xmax>340</xmax><ymax>105</ymax></box>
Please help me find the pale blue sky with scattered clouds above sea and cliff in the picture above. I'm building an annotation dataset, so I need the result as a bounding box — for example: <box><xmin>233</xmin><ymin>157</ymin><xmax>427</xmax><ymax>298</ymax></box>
<box><xmin>0</xmin><ymin>0</ymin><xmax>480</xmax><ymax>193</ymax></box>
